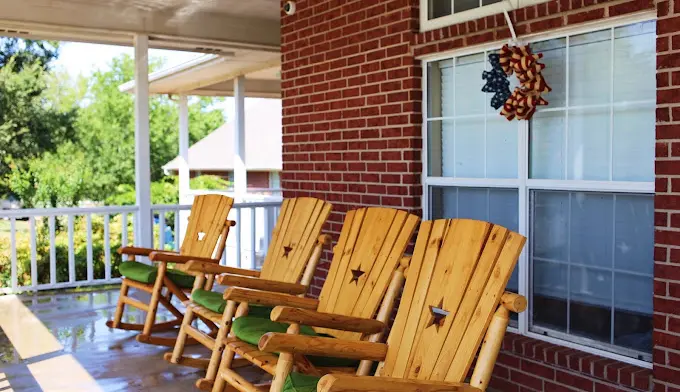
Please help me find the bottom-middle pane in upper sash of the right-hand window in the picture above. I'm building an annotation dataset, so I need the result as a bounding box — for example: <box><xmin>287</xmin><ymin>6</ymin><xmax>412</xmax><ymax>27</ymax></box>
<box><xmin>567</xmin><ymin>109</ymin><xmax>611</xmax><ymax>181</ymax></box>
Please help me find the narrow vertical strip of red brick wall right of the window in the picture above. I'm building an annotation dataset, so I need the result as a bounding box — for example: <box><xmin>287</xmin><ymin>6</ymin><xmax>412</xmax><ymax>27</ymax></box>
<box><xmin>654</xmin><ymin>0</ymin><xmax>680</xmax><ymax>392</ymax></box>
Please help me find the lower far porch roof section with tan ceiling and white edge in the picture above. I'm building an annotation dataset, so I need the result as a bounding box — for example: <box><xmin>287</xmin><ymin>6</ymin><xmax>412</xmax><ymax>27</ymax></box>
<box><xmin>120</xmin><ymin>51</ymin><xmax>281</xmax><ymax>98</ymax></box>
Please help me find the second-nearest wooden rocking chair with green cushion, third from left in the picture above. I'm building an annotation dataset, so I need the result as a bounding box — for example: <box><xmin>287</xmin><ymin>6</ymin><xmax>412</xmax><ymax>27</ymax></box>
<box><xmin>212</xmin><ymin>207</ymin><xmax>419</xmax><ymax>391</ymax></box>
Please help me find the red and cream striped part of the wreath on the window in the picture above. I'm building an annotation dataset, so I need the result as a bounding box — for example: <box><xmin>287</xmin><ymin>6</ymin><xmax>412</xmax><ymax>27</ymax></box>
<box><xmin>500</xmin><ymin>45</ymin><xmax>552</xmax><ymax>120</ymax></box>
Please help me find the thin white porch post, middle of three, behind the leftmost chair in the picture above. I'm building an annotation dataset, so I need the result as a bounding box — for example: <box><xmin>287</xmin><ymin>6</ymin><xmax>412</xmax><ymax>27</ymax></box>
<box><xmin>177</xmin><ymin>94</ymin><xmax>192</xmax><ymax>244</ymax></box>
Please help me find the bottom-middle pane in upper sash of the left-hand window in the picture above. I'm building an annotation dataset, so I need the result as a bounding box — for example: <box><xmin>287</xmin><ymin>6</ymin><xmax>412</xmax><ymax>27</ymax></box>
<box><xmin>454</xmin><ymin>118</ymin><xmax>484</xmax><ymax>178</ymax></box>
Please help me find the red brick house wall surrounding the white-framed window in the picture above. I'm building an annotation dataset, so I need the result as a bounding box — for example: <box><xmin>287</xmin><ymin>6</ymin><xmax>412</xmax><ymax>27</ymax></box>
<box><xmin>281</xmin><ymin>0</ymin><xmax>680</xmax><ymax>392</ymax></box>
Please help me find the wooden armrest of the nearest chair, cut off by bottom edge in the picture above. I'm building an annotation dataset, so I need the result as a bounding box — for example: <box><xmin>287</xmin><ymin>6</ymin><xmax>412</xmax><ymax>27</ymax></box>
<box><xmin>317</xmin><ymin>374</ymin><xmax>482</xmax><ymax>392</ymax></box>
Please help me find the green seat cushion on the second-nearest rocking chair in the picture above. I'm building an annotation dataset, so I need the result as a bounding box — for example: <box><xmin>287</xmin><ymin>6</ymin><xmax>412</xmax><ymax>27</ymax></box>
<box><xmin>231</xmin><ymin>315</ymin><xmax>359</xmax><ymax>367</ymax></box>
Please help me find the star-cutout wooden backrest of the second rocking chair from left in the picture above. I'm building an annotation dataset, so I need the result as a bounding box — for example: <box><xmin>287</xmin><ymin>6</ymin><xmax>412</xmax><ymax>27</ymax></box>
<box><xmin>260</xmin><ymin>197</ymin><xmax>332</xmax><ymax>283</ymax></box>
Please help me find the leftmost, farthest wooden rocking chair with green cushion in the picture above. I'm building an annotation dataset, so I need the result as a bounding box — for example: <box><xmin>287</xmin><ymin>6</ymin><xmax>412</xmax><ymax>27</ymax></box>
<box><xmin>106</xmin><ymin>195</ymin><xmax>239</xmax><ymax>346</ymax></box>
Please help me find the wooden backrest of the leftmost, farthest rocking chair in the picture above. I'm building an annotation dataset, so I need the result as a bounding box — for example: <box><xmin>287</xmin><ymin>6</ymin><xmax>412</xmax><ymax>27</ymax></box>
<box><xmin>180</xmin><ymin>195</ymin><xmax>234</xmax><ymax>257</ymax></box>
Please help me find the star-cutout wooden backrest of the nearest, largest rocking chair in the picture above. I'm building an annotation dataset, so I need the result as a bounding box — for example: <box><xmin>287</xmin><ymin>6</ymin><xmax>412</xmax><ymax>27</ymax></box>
<box><xmin>378</xmin><ymin>219</ymin><xmax>526</xmax><ymax>382</ymax></box>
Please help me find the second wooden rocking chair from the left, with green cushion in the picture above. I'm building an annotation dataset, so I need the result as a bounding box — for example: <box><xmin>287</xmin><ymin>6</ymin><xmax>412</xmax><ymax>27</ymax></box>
<box><xmin>164</xmin><ymin>197</ymin><xmax>332</xmax><ymax>390</ymax></box>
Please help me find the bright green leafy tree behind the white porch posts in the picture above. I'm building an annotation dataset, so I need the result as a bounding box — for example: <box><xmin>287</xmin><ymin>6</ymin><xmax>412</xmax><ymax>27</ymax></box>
<box><xmin>77</xmin><ymin>55</ymin><xmax>224</xmax><ymax>201</ymax></box>
